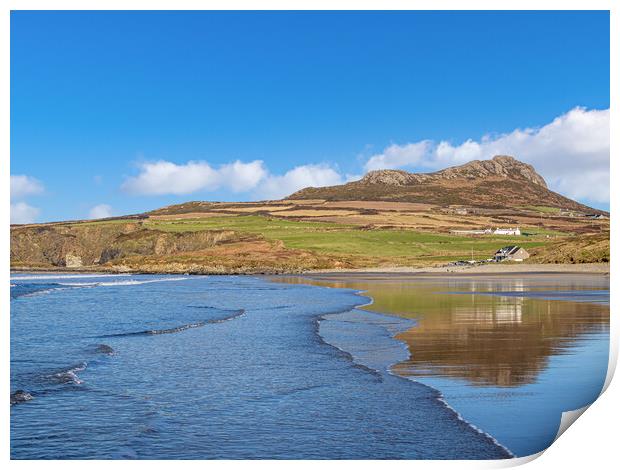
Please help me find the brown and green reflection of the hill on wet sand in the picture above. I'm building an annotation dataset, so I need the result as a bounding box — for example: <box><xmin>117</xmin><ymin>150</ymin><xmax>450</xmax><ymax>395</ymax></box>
<box><xmin>274</xmin><ymin>274</ymin><xmax>609</xmax><ymax>387</ymax></box>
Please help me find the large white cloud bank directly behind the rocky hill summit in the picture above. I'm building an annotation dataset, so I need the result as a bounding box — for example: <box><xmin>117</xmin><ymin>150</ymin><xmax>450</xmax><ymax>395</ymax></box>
<box><xmin>365</xmin><ymin>107</ymin><xmax>609</xmax><ymax>203</ymax></box>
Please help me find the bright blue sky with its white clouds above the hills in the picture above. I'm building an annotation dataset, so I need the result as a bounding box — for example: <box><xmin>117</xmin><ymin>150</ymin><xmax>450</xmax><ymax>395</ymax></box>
<box><xmin>11</xmin><ymin>12</ymin><xmax>609</xmax><ymax>221</ymax></box>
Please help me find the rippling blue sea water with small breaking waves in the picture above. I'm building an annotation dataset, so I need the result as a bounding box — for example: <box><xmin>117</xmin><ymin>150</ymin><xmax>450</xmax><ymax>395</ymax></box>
<box><xmin>11</xmin><ymin>274</ymin><xmax>511</xmax><ymax>459</ymax></box>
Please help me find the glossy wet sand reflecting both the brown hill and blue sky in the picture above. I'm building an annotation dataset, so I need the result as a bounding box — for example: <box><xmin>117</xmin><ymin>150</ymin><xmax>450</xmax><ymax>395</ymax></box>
<box><xmin>275</xmin><ymin>270</ymin><xmax>609</xmax><ymax>456</ymax></box>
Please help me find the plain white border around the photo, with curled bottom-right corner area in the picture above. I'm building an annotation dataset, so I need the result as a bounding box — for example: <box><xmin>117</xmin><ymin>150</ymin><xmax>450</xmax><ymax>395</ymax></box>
<box><xmin>0</xmin><ymin>0</ymin><xmax>620</xmax><ymax>469</ymax></box>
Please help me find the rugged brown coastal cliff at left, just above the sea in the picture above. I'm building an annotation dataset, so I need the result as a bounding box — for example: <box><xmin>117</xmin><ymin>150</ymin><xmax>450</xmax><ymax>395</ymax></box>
<box><xmin>11</xmin><ymin>222</ymin><xmax>352</xmax><ymax>274</ymax></box>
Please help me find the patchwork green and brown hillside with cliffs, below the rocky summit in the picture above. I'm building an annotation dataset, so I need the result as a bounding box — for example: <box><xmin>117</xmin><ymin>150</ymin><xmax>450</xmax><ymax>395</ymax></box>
<box><xmin>11</xmin><ymin>196</ymin><xmax>609</xmax><ymax>273</ymax></box>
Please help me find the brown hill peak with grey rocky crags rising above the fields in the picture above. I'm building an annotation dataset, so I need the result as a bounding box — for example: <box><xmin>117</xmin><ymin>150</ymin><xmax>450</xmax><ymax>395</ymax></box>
<box><xmin>287</xmin><ymin>155</ymin><xmax>593</xmax><ymax>211</ymax></box>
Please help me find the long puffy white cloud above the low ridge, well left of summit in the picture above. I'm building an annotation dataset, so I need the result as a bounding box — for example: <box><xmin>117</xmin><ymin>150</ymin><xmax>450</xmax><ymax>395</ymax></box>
<box><xmin>121</xmin><ymin>160</ymin><xmax>267</xmax><ymax>195</ymax></box>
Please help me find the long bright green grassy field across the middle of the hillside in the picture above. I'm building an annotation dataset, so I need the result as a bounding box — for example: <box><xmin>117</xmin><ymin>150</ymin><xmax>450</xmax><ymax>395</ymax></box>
<box><xmin>144</xmin><ymin>215</ymin><xmax>545</xmax><ymax>261</ymax></box>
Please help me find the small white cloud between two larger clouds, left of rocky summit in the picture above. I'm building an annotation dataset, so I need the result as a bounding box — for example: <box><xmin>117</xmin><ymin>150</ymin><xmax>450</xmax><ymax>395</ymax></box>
<box><xmin>256</xmin><ymin>164</ymin><xmax>345</xmax><ymax>199</ymax></box>
